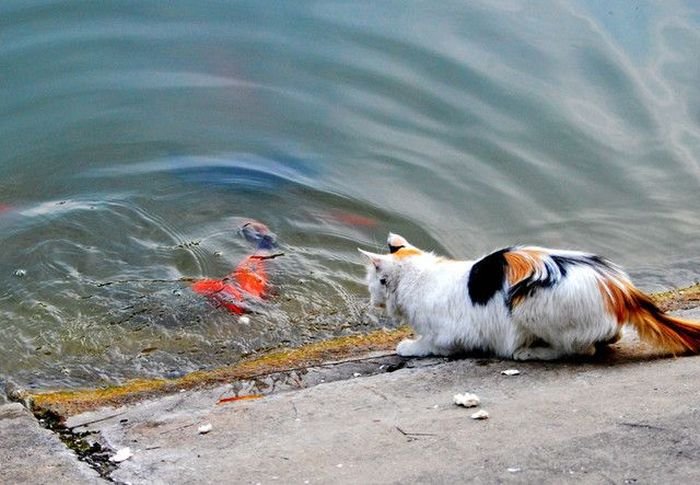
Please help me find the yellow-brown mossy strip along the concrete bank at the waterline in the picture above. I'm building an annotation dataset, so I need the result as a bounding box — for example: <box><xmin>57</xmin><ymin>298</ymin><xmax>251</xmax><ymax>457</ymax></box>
<box><xmin>8</xmin><ymin>283</ymin><xmax>700</xmax><ymax>418</ymax></box>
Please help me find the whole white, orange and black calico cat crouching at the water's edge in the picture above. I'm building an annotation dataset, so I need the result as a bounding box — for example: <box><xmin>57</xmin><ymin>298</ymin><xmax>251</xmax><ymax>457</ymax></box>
<box><xmin>358</xmin><ymin>233</ymin><xmax>700</xmax><ymax>360</ymax></box>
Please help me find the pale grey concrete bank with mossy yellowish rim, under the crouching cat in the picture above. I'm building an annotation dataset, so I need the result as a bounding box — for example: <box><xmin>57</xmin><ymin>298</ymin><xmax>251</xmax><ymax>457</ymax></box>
<box><xmin>0</xmin><ymin>285</ymin><xmax>700</xmax><ymax>483</ymax></box>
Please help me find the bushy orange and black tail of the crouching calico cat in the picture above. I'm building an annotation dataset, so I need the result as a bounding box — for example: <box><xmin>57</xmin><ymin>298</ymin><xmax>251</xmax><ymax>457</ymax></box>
<box><xmin>604</xmin><ymin>285</ymin><xmax>700</xmax><ymax>354</ymax></box>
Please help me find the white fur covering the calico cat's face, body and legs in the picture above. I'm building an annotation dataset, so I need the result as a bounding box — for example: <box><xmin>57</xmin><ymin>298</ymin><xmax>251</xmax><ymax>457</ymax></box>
<box><xmin>362</xmin><ymin>242</ymin><xmax>625</xmax><ymax>360</ymax></box>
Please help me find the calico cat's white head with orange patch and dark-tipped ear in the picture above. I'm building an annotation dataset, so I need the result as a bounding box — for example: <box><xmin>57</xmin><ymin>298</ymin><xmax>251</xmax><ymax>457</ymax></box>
<box><xmin>357</xmin><ymin>233</ymin><xmax>423</xmax><ymax>307</ymax></box>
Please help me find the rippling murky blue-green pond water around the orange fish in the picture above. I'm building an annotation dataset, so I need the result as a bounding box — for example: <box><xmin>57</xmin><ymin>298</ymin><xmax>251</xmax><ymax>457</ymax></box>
<box><xmin>0</xmin><ymin>0</ymin><xmax>700</xmax><ymax>394</ymax></box>
